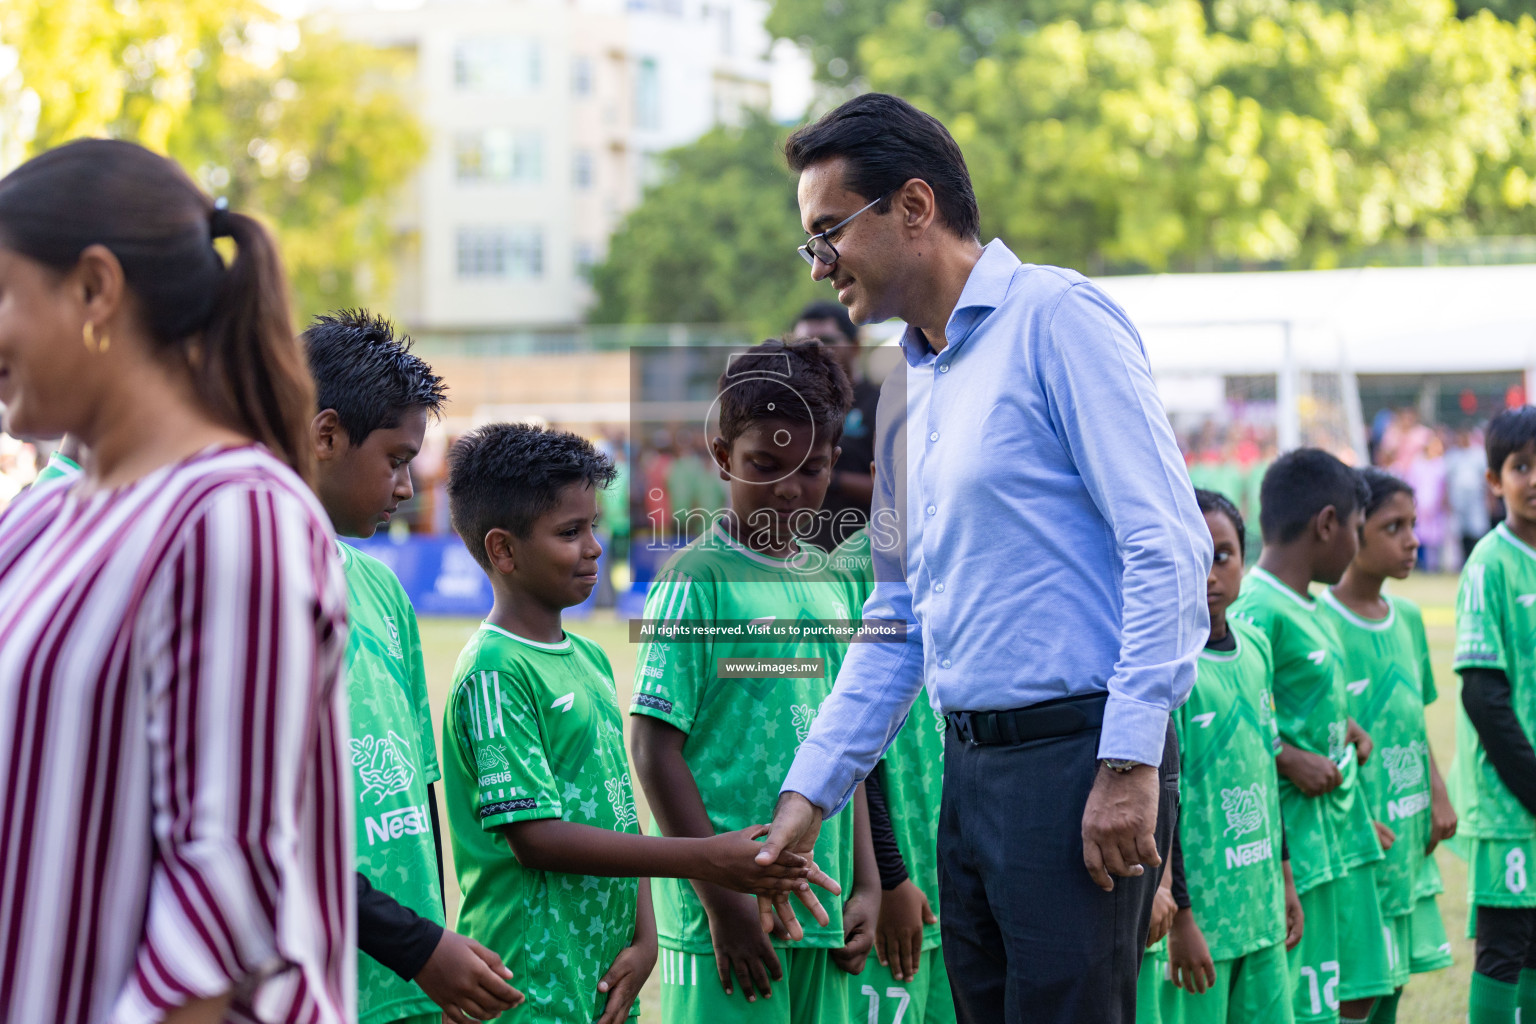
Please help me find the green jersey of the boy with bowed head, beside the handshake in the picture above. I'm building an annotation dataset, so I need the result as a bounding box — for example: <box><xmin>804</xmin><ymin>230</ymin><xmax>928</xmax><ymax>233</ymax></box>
<box><xmin>630</xmin><ymin>527</ymin><xmax>859</xmax><ymax>953</ymax></box>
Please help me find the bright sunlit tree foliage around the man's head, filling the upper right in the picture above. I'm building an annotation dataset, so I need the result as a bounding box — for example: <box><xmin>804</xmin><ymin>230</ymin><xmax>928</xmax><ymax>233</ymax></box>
<box><xmin>599</xmin><ymin>0</ymin><xmax>1536</xmax><ymax>319</ymax></box>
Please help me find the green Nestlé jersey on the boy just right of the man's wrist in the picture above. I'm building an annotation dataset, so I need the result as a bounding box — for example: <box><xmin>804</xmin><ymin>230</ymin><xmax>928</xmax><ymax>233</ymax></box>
<box><xmin>1174</xmin><ymin>620</ymin><xmax>1295</xmax><ymax>960</ymax></box>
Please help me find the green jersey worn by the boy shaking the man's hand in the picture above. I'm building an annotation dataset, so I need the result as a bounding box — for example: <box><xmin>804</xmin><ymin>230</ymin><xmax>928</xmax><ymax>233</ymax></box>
<box><xmin>442</xmin><ymin>622</ymin><xmax>639</xmax><ymax>1024</ymax></box>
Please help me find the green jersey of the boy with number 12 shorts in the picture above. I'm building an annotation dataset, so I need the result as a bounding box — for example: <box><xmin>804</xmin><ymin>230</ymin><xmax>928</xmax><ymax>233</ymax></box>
<box><xmin>1229</xmin><ymin>568</ymin><xmax>1351</xmax><ymax>892</ymax></box>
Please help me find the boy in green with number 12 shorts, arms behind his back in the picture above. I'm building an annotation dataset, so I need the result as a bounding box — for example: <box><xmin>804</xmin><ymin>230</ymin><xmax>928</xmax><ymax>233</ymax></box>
<box><xmin>1233</xmin><ymin>448</ymin><xmax>1392</xmax><ymax>1024</ymax></box>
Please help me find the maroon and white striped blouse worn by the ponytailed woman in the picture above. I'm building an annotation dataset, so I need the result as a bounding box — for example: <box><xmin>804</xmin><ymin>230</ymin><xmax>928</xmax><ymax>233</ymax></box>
<box><xmin>0</xmin><ymin>445</ymin><xmax>356</xmax><ymax>1024</ymax></box>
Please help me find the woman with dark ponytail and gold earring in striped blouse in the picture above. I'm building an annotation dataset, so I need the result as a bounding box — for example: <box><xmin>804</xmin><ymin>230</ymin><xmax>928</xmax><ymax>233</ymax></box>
<box><xmin>0</xmin><ymin>140</ymin><xmax>353</xmax><ymax>1024</ymax></box>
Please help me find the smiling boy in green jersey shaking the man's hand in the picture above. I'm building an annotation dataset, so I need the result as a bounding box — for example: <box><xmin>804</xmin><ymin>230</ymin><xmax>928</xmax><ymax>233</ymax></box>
<box><xmin>444</xmin><ymin>424</ymin><xmax>826</xmax><ymax>1024</ymax></box>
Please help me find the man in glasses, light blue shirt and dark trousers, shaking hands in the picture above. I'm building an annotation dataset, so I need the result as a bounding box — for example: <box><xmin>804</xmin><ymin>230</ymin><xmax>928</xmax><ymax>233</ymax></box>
<box><xmin>762</xmin><ymin>94</ymin><xmax>1210</xmax><ymax>1024</ymax></box>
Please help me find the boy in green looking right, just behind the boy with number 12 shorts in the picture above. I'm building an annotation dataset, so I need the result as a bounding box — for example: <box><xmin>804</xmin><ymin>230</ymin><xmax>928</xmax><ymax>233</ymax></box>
<box><xmin>1321</xmin><ymin>468</ymin><xmax>1456</xmax><ymax>1024</ymax></box>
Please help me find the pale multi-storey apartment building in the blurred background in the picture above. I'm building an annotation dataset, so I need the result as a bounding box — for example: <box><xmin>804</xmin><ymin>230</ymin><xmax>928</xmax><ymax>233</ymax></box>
<box><xmin>316</xmin><ymin>0</ymin><xmax>809</xmax><ymax>341</ymax></box>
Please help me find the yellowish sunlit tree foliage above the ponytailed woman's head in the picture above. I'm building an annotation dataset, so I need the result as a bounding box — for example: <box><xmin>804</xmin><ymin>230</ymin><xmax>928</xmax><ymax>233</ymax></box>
<box><xmin>0</xmin><ymin>0</ymin><xmax>425</xmax><ymax>318</ymax></box>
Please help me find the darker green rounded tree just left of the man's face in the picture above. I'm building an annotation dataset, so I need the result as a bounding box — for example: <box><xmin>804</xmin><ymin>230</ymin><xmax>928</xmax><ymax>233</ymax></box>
<box><xmin>590</xmin><ymin>115</ymin><xmax>829</xmax><ymax>336</ymax></box>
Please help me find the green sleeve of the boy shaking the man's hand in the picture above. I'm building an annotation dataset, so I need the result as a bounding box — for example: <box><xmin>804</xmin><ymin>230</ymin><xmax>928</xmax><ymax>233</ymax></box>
<box><xmin>450</xmin><ymin>669</ymin><xmax>564</xmax><ymax>832</ymax></box>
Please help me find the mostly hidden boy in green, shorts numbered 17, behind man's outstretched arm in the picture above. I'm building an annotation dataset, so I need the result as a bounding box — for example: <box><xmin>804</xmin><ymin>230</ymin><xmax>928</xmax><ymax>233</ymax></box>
<box><xmin>833</xmin><ymin>521</ymin><xmax>955</xmax><ymax>1024</ymax></box>
